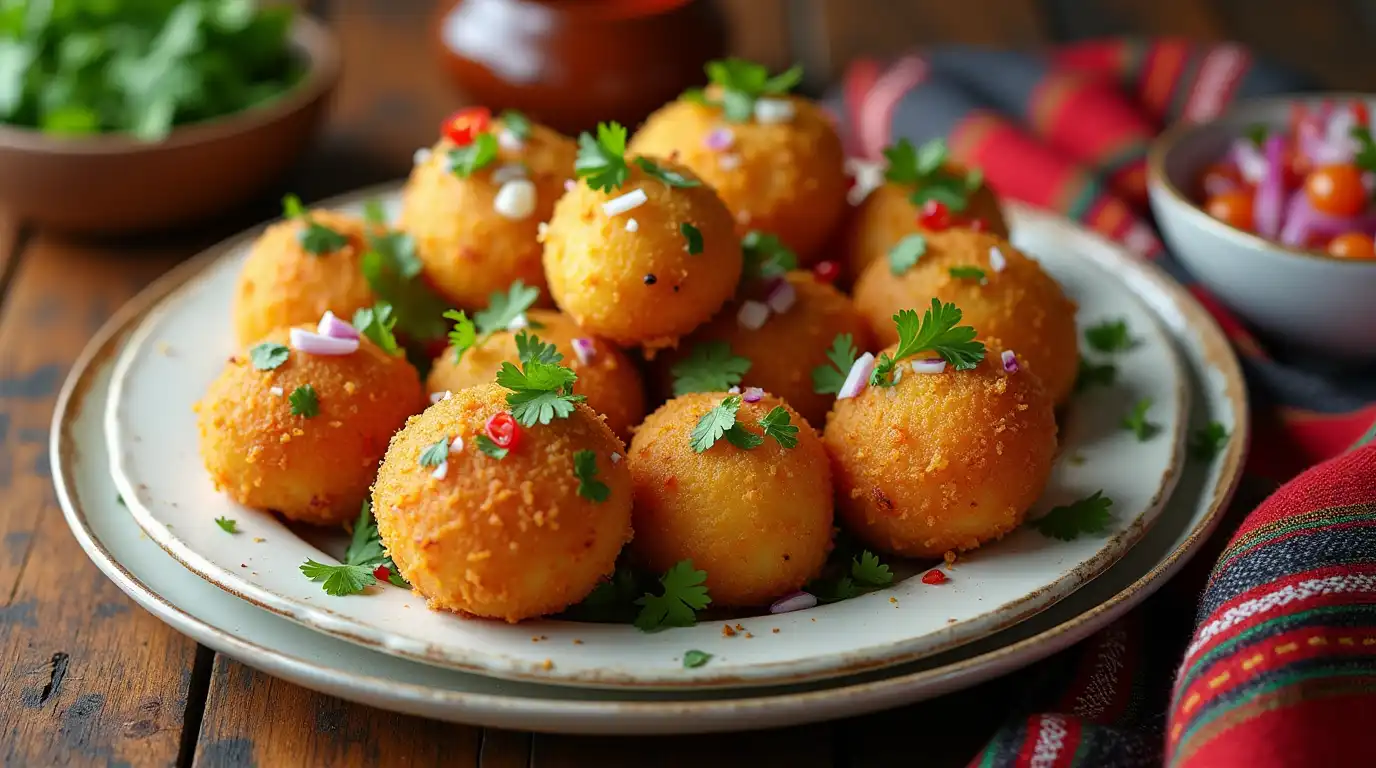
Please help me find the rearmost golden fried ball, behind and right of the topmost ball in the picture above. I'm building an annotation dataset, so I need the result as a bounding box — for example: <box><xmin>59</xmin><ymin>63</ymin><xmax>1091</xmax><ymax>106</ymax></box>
<box><xmin>630</xmin><ymin>96</ymin><xmax>849</xmax><ymax>264</ymax></box>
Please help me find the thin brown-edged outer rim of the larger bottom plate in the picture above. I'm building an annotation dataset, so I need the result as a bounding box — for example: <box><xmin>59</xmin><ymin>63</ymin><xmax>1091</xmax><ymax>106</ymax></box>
<box><xmin>50</xmin><ymin>192</ymin><xmax>1249</xmax><ymax>714</ymax></box>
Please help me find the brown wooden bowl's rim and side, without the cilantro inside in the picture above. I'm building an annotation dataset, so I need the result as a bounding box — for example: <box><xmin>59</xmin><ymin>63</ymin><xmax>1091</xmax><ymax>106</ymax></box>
<box><xmin>0</xmin><ymin>17</ymin><xmax>340</xmax><ymax>234</ymax></box>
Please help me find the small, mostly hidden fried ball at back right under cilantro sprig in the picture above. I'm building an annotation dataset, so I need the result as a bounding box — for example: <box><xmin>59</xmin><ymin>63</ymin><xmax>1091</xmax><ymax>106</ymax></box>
<box><xmin>845</xmin><ymin>177</ymin><xmax>1009</xmax><ymax>279</ymax></box>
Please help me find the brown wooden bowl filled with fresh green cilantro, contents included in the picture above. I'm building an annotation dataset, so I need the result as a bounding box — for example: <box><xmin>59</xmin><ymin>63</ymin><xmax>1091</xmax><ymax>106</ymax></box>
<box><xmin>0</xmin><ymin>0</ymin><xmax>340</xmax><ymax>233</ymax></box>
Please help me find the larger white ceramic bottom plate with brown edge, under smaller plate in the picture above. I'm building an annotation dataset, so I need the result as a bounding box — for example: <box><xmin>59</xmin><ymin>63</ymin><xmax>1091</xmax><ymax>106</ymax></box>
<box><xmin>51</xmin><ymin>205</ymin><xmax>1247</xmax><ymax>734</ymax></box>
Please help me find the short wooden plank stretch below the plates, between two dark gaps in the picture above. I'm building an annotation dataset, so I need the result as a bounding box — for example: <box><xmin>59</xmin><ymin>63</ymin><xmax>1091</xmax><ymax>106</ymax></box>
<box><xmin>193</xmin><ymin>655</ymin><xmax>482</xmax><ymax>768</ymax></box>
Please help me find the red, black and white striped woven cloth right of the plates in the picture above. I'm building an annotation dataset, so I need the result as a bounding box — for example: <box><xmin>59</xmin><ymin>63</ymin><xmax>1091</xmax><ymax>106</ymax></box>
<box><xmin>830</xmin><ymin>40</ymin><xmax>1376</xmax><ymax>768</ymax></box>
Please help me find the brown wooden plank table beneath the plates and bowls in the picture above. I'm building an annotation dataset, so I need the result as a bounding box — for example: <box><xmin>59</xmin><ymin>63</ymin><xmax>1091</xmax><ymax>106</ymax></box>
<box><xmin>0</xmin><ymin>0</ymin><xmax>1353</xmax><ymax>768</ymax></box>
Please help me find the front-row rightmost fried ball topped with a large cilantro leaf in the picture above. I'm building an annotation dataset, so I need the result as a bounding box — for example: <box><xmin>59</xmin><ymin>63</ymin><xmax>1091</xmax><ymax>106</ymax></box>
<box><xmin>823</xmin><ymin>347</ymin><xmax>1057</xmax><ymax>557</ymax></box>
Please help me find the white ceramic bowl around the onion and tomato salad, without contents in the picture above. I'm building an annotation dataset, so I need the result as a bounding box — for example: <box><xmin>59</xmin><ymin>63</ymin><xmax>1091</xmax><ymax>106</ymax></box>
<box><xmin>1148</xmin><ymin>94</ymin><xmax>1376</xmax><ymax>359</ymax></box>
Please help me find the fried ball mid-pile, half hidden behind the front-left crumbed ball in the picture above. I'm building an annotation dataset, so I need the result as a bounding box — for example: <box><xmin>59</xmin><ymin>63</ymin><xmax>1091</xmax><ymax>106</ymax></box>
<box><xmin>425</xmin><ymin>310</ymin><xmax>645</xmax><ymax>439</ymax></box>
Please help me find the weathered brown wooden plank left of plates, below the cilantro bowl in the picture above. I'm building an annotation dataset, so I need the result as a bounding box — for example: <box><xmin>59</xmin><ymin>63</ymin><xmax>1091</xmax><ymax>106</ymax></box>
<box><xmin>0</xmin><ymin>235</ymin><xmax>195</xmax><ymax>765</ymax></box>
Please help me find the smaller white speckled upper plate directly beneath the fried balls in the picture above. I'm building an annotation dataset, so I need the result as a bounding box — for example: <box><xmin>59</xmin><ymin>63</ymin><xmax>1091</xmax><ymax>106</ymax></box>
<box><xmin>106</xmin><ymin>187</ymin><xmax>1189</xmax><ymax>690</ymax></box>
